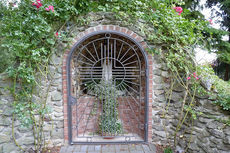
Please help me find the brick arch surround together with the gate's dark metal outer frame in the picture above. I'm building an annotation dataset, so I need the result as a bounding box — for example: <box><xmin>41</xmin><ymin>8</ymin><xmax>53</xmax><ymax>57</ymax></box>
<box><xmin>62</xmin><ymin>25</ymin><xmax>153</xmax><ymax>144</ymax></box>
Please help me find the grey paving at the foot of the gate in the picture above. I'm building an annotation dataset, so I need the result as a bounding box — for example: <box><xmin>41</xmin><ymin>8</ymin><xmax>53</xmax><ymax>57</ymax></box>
<box><xmin>60</xmin><ymin>144</ymin><xmax>156</xmax><ymax>153</ymax></box>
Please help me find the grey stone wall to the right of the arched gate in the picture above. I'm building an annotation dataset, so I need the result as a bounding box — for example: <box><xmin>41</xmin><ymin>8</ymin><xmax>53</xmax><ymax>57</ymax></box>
<box><xmin>152</xmin><ymin>56</ymin><xmax>230</xmax><ymax>153</ymax></box>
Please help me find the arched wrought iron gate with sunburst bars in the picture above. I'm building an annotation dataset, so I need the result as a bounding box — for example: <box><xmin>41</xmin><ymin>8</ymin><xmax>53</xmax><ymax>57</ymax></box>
<box><xmin>67</xmin><ymin>31</ymin><xmax>148</xmax><ymax>143</ymax></box>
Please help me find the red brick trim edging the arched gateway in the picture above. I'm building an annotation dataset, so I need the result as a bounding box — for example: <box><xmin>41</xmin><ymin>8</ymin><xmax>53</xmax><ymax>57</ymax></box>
<box><xmin>62</xmin><ymin>25</ymin><xmax>153</xmax><ymax>142</ymax></box>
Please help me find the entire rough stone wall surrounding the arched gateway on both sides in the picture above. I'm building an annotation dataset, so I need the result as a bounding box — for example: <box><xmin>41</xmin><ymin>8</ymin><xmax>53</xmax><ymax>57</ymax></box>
<box><xmin>0</xmin><ymin>13</ymin><xmax>230</xmax><ymax>153</ymax></box>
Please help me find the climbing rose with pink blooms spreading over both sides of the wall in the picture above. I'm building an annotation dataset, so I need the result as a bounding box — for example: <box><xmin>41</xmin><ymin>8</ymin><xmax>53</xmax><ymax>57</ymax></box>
<box><xmin>0</xmin><ymin>0</ymin><xmax>230</xmax><ymax>152</ymax></box>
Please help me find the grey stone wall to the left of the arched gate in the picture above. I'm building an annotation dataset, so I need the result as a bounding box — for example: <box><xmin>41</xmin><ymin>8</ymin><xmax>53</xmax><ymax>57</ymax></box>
<box><xmin>0</xmin><ymin>50</ymin><xmax>64</xmax><ymax>153</ymax></box>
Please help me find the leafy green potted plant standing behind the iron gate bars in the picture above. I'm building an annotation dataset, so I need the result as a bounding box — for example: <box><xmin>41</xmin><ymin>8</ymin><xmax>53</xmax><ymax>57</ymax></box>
<box><xmin>93</xmin><ymin>80</ymin><xmax>122</xmax><ymax>136</ymax></box>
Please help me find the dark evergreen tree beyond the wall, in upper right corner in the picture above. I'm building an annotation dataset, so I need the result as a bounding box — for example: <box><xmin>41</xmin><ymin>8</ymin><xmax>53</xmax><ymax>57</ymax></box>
<box><xmin>184</xmin><ymin>0</ymin><xmax>230</xmax><ymax>81</ymax></box>
